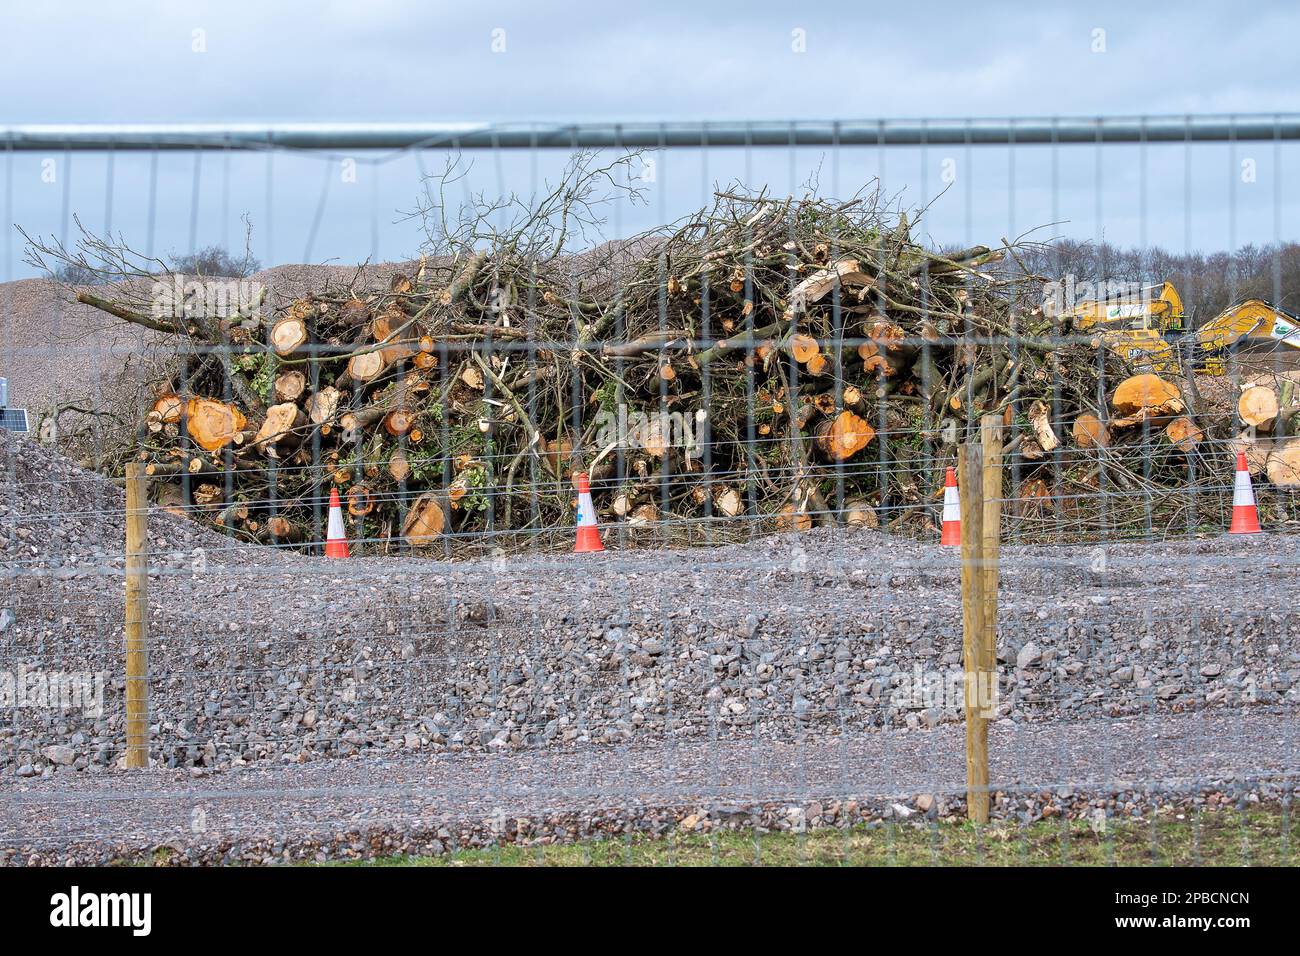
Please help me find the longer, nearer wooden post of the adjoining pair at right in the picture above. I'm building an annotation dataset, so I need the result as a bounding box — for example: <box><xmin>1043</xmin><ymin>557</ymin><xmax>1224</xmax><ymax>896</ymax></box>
<box><xmin>957</xmin><ymin>444</ymin><xmax>988</xmax><ymax>823</ymax></box>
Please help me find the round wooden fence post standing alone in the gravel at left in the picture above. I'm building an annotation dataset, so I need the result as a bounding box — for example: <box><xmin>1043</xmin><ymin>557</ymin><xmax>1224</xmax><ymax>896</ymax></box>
<box><xmin>126</xmin><ymin>462</ymin><xmax>150</xmax><ymax>767</ymax></box>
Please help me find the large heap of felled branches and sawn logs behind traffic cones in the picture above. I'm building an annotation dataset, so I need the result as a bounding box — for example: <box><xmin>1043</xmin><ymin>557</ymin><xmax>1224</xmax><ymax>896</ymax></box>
<box><xmin>29</xmin><ymin>155</ymin><xmax>1279</xmax><ymax>553</ymax></box>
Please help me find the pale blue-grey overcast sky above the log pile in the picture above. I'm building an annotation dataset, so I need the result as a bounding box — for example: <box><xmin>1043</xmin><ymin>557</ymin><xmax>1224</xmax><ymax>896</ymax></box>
<box><xmin>0</xmin><ymin>0</ymin><xmax>1300</xmax><ymax>276</ymax></box>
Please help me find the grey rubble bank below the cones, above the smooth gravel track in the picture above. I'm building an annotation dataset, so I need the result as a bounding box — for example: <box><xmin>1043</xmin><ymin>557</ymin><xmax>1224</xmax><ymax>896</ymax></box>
<box><xmin>0</xmin><ymin>429</ymin><xmax>1300</xmax><ymax>779</ymax></box>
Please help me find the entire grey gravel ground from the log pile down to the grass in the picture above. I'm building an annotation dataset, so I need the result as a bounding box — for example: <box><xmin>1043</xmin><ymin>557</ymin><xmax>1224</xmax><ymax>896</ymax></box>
<box><xmin>0</xmin><ymin>434</ymin><xmax>1300</xmax><ymax>862</ymax></box>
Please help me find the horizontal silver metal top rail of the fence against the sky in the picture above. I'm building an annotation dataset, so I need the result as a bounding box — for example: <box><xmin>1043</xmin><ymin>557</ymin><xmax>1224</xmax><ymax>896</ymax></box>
<box><xmin>0</xmin><ymin>113</ymin><xmax>1300</xmax><ymax>151</ymax></box>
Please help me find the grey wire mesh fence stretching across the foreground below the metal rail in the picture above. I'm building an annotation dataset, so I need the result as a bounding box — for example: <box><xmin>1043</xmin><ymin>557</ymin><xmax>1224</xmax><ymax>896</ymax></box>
<box><xmin>0</xmin><ymin>117</ymin><xmax>1300</xmax><ymax>862</ymax></box>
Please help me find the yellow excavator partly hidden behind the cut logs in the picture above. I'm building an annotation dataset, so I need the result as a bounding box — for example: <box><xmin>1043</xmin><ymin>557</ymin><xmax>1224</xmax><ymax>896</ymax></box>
<box><xmin>1062</xmin><ymin>282</ymin><xmax>1300</xmax><ymax>375</ymax></box>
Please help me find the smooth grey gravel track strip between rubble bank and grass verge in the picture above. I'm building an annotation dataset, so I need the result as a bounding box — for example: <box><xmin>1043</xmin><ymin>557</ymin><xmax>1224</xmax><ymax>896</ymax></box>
<box><xmin>0</xmin><ymin>710</ymin><xmax>1300</xmax><ymax>865</ymax></box>
